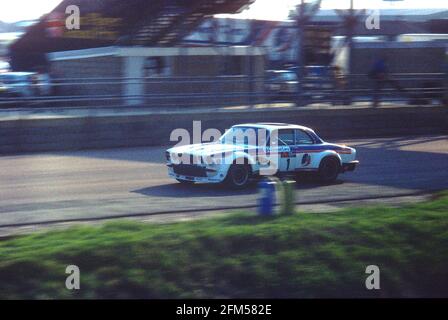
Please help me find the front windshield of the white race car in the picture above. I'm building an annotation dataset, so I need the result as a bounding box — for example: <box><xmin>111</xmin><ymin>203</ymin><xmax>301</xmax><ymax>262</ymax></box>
<box><xmin>219</xmin><ymin>127</ymin><xmax>269</xmax><ymax>146</ymax></box>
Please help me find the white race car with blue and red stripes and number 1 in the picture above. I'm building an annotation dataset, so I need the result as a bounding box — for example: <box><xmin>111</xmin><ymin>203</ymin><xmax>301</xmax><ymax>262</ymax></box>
<box><xmin>166</xmin><ymin>123</ymin><xmax>359</xmax><ymax>189</ymax></box>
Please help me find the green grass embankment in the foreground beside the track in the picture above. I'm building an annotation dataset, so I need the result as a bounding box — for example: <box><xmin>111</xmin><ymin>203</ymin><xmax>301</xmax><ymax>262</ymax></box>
<box><xmin>0</xmin><ymin>193</ymin><xmax>448</xmax><ymax>299</ymax></box>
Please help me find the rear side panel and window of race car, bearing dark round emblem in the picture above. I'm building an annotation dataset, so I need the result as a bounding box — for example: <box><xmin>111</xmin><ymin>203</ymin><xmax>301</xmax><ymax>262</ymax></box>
<box><xmin>291</xmin><ymin>129</ymin><xmax>317</xmax><ymax>171</ymax></box>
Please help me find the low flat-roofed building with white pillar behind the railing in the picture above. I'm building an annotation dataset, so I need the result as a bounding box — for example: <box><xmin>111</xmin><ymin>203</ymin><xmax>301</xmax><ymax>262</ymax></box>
<box><xmin>49</xmin><ymin>47</ymin><xmax>265</xmax><ymax>106</ymax></box>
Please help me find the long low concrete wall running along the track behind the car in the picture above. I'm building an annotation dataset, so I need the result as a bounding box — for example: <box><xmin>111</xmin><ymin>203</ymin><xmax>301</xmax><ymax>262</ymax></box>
<box><xmin>0</xmin><ymin>107</ymin><xmax>448</xmax><ymax>155</ymax></box>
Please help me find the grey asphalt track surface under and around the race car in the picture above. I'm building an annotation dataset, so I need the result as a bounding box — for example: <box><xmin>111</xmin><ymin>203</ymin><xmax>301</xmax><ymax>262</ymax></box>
<box><xmin>0</xmin><ymin>136</ymin><xmax>448</xmax><ymax>227</ymax></box>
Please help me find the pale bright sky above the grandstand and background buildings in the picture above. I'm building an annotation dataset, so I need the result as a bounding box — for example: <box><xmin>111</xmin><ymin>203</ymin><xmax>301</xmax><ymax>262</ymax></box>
<box><xmin>0</xmin><ymin>0</ymin><xmax>448</xmax><ymax>22</ymax></box>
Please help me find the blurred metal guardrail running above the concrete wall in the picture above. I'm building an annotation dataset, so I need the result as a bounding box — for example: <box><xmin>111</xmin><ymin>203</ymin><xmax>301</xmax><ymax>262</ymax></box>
<box><xmin>0</xmin><ymin>73</ymin><xmax>448</xmax><ymax>108</ymax></box>
